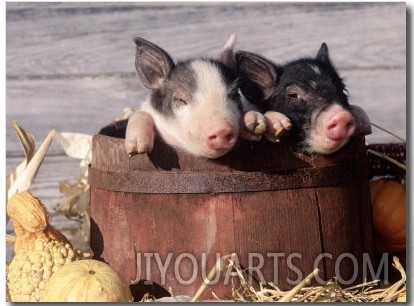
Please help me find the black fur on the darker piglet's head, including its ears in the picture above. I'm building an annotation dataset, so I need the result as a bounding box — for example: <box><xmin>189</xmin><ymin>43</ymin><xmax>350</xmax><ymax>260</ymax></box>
<box><xmin>236</xmin><ymin>43</ymin><xmax>349</xmax><ymax>140</ymax></box>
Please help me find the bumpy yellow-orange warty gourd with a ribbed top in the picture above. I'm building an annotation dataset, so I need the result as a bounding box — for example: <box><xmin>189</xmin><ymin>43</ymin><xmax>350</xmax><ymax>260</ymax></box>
<box><xmin>7</xmin><ymin>191</ymin><xmax>83</xmax><ymax>302</ymax></box>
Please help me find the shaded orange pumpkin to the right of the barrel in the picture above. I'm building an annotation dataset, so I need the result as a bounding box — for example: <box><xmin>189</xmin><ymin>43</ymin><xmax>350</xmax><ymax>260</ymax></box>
<box><xmin>370</xmin><ymin>178</ymin><xmax>406</xmax><ymax>253</ymax></box>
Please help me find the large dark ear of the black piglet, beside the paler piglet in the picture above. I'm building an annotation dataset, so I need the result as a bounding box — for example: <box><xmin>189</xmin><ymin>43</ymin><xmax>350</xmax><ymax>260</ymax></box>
<box><xmin>236</xmin><ymin>51</ymin><xmax>278</xmax><ymax>103</ymax></box>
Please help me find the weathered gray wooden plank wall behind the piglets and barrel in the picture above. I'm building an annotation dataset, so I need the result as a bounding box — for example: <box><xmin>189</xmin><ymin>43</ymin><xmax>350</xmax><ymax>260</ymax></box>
<box><xmin>6</xmin><ymin>2</ymin><xmax>406</xmax><ymax>256</ymax></box>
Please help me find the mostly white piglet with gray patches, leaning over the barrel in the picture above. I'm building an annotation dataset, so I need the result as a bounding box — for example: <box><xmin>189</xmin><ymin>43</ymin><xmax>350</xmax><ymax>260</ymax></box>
<box><xmin>125</xmin><ymin>34</ymin><xmax>266</xmax><ymax>158</ymax></box>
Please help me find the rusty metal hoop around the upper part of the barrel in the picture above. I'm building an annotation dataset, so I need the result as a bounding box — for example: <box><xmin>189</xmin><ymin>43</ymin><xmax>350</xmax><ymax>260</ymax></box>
<box><xmin>88</xmin><ymin>159</ymin><xmax>368</xmax><ymax>194</ymax></box>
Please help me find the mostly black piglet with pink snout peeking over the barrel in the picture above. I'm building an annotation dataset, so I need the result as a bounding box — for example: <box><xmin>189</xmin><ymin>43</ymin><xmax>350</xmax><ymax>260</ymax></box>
<box><xmin>236</xmin><ymin>43</ymin><xmax>371</xmax><ymax>154</ymax></box>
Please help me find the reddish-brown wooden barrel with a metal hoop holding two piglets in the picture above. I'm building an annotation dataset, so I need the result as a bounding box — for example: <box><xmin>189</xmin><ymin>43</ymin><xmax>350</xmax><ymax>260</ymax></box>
<box><xmin>89</xmin><ymin>121</ymin><xmax>375</xmax><ymax>300</ymax></box>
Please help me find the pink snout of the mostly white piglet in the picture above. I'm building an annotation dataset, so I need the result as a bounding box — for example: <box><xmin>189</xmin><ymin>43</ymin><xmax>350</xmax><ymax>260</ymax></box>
<box><xmin>205</xmin><ymin>124</ymin><xmax>237</xmax><ymax>150</ymax></box>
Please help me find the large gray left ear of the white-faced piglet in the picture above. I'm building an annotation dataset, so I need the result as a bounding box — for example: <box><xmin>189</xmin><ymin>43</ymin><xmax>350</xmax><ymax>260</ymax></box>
<box><xmin>134</xmin><ymin>37</ymin><xmax>174</xmax><ymax>89</ymax></box>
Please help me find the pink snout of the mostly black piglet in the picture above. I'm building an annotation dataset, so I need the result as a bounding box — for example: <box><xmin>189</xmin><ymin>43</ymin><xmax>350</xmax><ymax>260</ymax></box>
<box><xmin>325</xmin><ymin>112</ymin><xmax>356</xmax><ymax>140</ymax></box>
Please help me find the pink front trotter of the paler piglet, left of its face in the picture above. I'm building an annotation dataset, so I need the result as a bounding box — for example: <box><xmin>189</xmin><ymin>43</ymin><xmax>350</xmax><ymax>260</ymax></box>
<box><xmin>125</xmin><ymin>111</ymin><xmax>156</xmax><ymax>156</ymax></box>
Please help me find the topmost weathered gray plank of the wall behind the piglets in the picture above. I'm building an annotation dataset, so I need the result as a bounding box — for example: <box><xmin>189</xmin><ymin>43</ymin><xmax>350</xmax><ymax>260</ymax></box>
<box><xmin>6</xmin><ymin>3</ymin><xmax>406</xmax><ymax>76</ymax></box>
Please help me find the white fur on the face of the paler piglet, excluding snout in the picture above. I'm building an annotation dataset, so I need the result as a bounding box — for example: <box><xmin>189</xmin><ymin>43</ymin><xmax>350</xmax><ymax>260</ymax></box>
<box><xmin>141</xmin><ymin>60</ymin><xmax>241</xmax><ymax>158</ymax></box>
